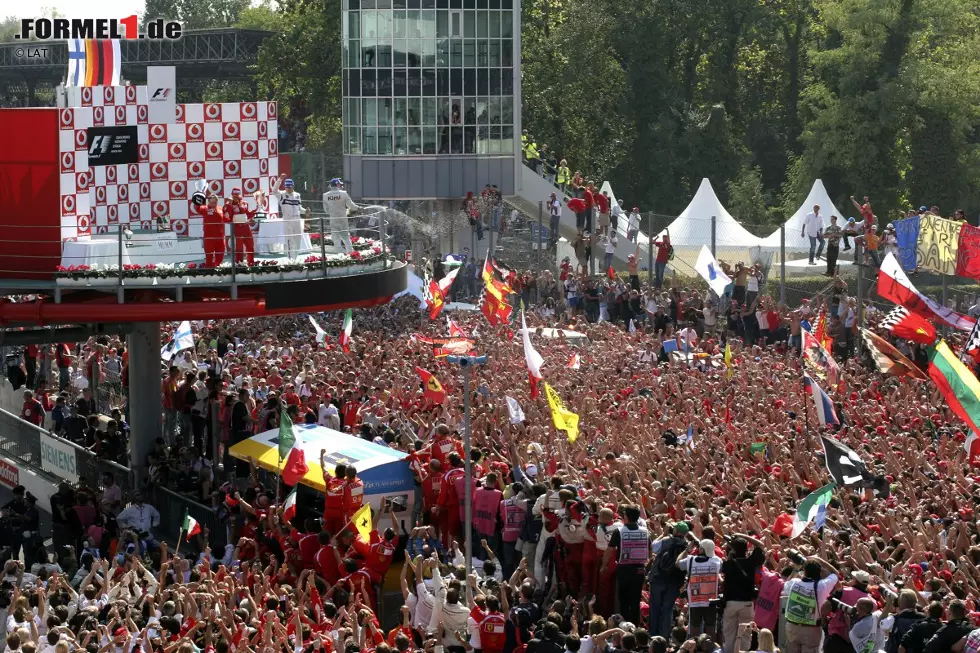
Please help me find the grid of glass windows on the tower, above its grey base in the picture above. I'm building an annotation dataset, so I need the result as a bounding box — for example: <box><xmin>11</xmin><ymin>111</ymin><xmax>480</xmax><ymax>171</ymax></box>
<box><xmin>342</xmin><ymin>5</ymin><xmax>514</xmax><ymax>155</ymax></box>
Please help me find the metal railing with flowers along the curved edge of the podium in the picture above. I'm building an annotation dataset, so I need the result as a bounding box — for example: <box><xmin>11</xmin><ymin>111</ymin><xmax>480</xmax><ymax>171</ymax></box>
<box><xmin>0</xmin><ymin>202</ymin><xmax>391</xmax><ymax>287</ymax></box>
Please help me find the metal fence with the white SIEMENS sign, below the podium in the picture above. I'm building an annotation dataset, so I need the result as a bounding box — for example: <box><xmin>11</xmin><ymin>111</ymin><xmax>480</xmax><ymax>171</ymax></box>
<box><xmin>0</xmin><ymin>410</ymin><xmax>135</xmax><ymax>493</ymax></box>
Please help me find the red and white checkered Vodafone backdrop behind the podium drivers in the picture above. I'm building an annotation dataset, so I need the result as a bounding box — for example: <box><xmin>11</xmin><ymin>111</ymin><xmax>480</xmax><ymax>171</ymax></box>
<box><xmin>59</xmin><ymin>86</ymin><xmax>279</xmax><ymax>240</ymax></box>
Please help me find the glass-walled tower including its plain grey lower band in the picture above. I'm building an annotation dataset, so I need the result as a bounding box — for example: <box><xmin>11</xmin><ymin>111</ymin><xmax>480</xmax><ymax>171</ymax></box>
<box><xmin>343</xmin><ymin>0</ymin><xmax>520</xmax><ymax>199</ymax></box>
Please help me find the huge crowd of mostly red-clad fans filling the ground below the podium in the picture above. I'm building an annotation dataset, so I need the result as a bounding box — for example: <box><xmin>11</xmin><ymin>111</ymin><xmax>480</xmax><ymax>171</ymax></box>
<box><xmin>0</xmin><ymin>255</ymin><xmax>980</xmax><ymax>653</ymax></box>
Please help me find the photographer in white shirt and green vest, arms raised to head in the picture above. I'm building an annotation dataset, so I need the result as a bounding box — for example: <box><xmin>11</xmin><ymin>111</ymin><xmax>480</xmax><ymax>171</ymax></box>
<box><xmin>783</xmin><ymin>556</ymin><xmax>840</xmax><ymax>653</ymax></box>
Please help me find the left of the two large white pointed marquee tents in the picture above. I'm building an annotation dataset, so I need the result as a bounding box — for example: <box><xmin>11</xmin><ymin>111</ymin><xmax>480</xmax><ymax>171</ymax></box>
<box><xmin>657</xmin><ymin>177</ymin><xmax>761</xmax><ymax>249</ymax></box>
